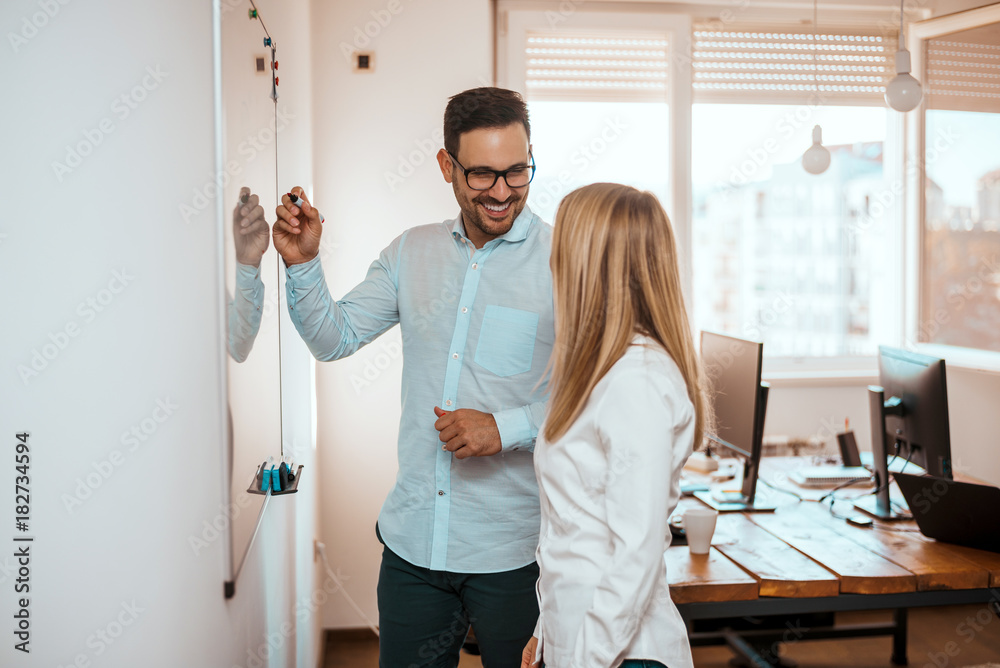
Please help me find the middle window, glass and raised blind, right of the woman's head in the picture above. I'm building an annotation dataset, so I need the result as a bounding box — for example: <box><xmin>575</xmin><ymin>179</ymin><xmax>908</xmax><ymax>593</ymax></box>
<box><xmin>691</xmin><ymin>27</ymin><xmax>897</xmax><ymax>358</ymax></box>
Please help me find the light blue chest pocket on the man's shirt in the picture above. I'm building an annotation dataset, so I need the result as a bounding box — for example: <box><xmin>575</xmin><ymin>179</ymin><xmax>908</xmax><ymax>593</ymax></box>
<box><xmin>476</xmin><ymin>306</ymin><xmax>538</xmax><ymax>376</ymax></box>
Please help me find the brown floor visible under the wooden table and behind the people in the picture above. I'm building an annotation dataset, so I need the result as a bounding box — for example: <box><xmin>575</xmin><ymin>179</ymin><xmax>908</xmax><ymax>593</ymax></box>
<box><xmin>323</xmin><ymin>605</ymin><xmax>1000</xmax><ymax>668</ymax></box>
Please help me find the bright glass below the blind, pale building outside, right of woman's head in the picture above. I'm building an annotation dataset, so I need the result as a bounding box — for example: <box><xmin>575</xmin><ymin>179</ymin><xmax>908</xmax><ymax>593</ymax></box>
<box><xmin>691</xmin><ymin>104</ymin><xmax>893</xmax><ymax>357</ymax></box>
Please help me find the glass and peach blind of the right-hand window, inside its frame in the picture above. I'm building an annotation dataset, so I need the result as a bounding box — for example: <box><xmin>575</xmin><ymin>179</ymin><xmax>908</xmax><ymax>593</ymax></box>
<box><xmin>917</xmin><ymin>24</ymin><xmax>1000</xmax><ymax>352</ymax></box>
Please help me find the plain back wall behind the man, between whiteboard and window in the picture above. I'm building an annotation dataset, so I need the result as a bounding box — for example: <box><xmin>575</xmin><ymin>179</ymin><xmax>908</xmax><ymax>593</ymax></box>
<box><xmin>312</xmin><ymin>0</ymin><xmax>492</xmax><ymax>627</ymax></box>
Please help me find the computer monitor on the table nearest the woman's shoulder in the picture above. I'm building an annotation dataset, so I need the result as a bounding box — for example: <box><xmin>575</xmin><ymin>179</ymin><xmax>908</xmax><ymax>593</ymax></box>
<box><xmin>696</xmin><ymin>332</ymin><xmax>774</xmax><ymax>511</ymax></box>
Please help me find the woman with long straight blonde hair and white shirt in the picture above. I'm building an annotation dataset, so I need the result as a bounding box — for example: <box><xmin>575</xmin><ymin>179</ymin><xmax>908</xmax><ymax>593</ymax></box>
<box><xmin>521</xmin><ymin>183</ymin><xmax>706</xmax><ymax>668</ymax></box>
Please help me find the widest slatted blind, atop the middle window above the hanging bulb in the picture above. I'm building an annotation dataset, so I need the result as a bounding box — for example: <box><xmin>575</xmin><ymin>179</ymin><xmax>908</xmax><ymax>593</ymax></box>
<box><xmin>692</xmin><ymin>25</ymin><xmax>896</xmax><ymax>105</ymax></box>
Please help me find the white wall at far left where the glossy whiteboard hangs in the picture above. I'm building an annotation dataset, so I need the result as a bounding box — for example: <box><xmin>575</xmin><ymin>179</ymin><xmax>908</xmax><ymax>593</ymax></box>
<box><xmin>0</xmin><ymin>0</ymin><xmax>318</xmax><ymax>668</ymax></box>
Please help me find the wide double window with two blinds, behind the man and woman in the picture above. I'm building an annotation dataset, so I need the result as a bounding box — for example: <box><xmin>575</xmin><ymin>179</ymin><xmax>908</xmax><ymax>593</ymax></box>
<box><xmin>498</xmin><ymin>7</ymin><xmax>916</xmax><ymax>371</ymax></box>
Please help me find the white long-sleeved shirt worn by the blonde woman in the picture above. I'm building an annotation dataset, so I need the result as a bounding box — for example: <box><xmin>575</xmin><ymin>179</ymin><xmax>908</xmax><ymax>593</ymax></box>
<box><xmin>535</xmin><ymin>336</ymin><xmax>694</xmax><ymax>668</ymax></box>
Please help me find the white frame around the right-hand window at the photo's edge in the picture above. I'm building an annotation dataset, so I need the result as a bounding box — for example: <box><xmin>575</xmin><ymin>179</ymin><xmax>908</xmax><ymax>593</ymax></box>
<box><xmin>912</xmin><ymin>5</ymin><xmax>1000</xmax><ymax>373</ymax></box>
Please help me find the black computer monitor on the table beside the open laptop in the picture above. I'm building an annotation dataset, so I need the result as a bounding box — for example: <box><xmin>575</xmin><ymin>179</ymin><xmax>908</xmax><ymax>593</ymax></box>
<box><xmin>854</xmin><ymin>346</ymin><xmax>952</xmax><ymax>520</ymax></box>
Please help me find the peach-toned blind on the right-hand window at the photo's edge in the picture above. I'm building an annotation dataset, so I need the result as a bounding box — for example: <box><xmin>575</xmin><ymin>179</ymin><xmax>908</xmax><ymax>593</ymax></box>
<box><xmin>924</xmin><ymin>30</ymin><xmax>1000</xmax><ymax>113</ymax></box>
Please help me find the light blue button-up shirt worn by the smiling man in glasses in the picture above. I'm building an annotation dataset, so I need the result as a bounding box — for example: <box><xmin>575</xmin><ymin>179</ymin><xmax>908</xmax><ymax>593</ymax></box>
<box><xmin>286</xmin><ymin>207</ymin><xmax>554</xmax><ymax>573</ymax></box>
